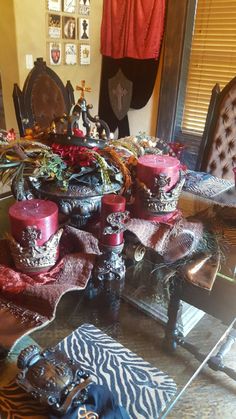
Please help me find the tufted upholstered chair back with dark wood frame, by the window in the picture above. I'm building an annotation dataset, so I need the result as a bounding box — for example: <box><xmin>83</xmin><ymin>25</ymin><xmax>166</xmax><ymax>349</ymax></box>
<box><xmin>196</xmin><ymin>77</ymin><xmax>236</xmax><ymax>180</ymax></box>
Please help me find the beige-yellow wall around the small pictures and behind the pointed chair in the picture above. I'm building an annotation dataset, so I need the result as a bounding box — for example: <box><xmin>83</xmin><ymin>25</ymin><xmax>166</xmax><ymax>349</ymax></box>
<box><xmin>0</xmin><ymin>0</ymin><xmax>160</xmax><ymax>135</ymax></box>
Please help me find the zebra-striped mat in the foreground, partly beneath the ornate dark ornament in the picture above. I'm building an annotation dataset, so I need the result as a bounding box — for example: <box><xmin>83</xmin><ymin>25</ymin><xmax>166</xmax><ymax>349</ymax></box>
<box><xmin>0</xmin><ymin>324</ymin><xmax>177</xmax><ymax>419</ymax></box>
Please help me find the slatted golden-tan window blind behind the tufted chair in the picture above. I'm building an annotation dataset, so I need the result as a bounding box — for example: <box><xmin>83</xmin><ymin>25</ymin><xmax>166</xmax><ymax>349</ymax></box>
<box><xmin>182</xmin><ymin>0</ymin><xmax>236</xmax><ymax>134</ymax></box>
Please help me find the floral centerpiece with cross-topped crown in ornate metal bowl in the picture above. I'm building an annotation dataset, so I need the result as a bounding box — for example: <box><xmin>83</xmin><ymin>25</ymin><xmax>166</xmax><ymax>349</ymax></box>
<box><xmin>1</xmin><ymin>81</ymin><xmax>124</xmax><ymax>227</ymax></box>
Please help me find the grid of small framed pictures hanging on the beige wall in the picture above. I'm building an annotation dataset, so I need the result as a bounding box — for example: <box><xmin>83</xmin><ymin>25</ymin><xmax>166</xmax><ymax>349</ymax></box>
<box><xmin>46</xmin><ymin>0</ymin><xmax>90</xmax><ymax>65</ymax></box>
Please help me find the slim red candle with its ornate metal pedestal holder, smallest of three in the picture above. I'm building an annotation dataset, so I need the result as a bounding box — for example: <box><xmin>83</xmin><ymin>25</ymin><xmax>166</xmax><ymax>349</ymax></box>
<box><xmin>95</xmin><ymin>194</ymin><xmax>129</xmax><ymax>281</ymax></box>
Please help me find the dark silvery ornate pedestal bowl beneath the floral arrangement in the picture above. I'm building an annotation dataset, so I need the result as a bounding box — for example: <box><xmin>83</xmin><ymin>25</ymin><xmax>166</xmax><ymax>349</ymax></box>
<box><xmin>30</xmin><ymin>179</ymin><xmax>121</xmax><ymax>228</ymax></box>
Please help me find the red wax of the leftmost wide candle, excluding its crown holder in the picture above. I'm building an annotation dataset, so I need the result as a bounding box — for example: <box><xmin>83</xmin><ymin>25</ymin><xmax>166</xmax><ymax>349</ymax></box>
<box><xmin>9</xmin><ymin>199</ymin><xmax>58</xmax><ymax>246</ymax></box>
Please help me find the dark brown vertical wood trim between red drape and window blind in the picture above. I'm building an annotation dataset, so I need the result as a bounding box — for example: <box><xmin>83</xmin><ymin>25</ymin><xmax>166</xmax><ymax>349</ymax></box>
<box><xmin>157</xmin><ymin>0</ymin><xmax>196</xmax><ymax>141</ymax></box>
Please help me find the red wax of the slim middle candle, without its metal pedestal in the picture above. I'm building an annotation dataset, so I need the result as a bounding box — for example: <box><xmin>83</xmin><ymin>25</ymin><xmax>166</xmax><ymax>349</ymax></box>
<box><xmin>100</xmin><ymin>194</ymin><xmax>126</xmax><ymax>246</ymax></box>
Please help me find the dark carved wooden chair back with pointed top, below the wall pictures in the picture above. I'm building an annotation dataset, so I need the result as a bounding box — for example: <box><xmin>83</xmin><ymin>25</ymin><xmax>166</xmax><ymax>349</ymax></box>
<box><xmin>13</xmin><ymin>58</ymin><xmax>75</xmax><ymax>137</ymax></box>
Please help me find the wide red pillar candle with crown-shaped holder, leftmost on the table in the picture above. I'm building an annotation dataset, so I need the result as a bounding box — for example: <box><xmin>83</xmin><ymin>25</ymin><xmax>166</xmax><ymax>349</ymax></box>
<box><xmin>8</xmin><ymin>199</ymin><xmax>62</xmax><ymax>275</ymax></box>
